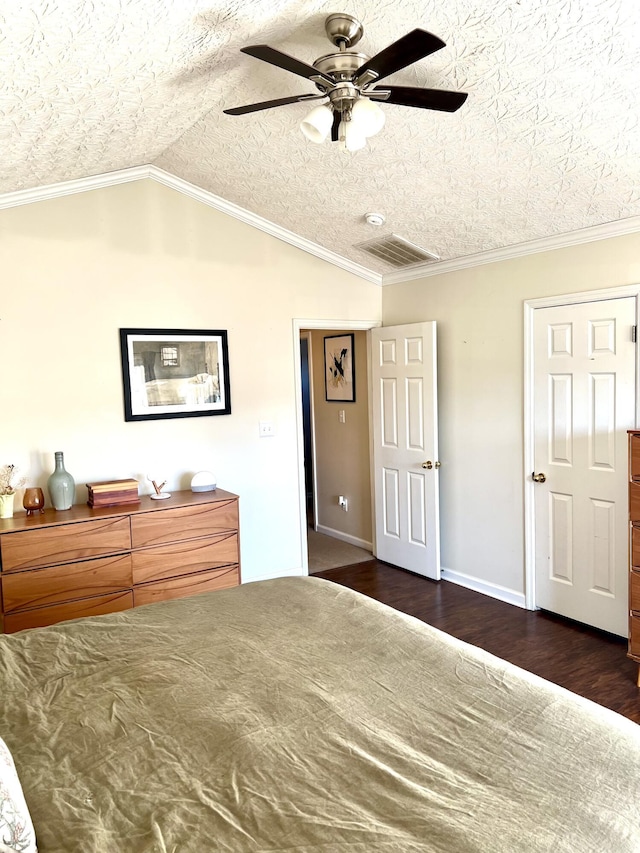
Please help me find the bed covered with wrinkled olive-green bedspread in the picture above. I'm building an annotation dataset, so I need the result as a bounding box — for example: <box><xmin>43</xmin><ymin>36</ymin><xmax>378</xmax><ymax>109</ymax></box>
<box><xmin>0</xmin><ymin>578</ymin><xmax>640</xmax><ymax>853</ymax></box>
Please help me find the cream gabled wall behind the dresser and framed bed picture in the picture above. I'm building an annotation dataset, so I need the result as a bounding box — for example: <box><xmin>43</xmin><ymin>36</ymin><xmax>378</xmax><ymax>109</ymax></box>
<box><xmin>0</xmin><ymin>181</ymin><xmax>381</xmax><ymax>580</ymax></box>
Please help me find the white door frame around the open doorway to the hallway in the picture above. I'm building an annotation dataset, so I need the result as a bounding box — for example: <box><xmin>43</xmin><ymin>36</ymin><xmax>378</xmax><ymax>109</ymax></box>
<box><xmin>293</xmin><ymin>317</ymin><xmax>382</xmax><ymax>575</ymax></box>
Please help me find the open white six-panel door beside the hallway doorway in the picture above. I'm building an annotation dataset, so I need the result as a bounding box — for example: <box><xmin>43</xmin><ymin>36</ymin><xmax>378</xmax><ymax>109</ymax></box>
<box><xmin>371</xmin><ymin>322</ymin><xmax>440</xmax><ymax>580</ymax></box>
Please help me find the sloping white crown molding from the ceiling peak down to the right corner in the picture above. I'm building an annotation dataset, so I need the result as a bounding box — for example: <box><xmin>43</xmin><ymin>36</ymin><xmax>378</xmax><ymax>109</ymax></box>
<box><xmin>149</xmin><ymin>166</ymin><xmax>382</xmax><ymax>285</ymax></box>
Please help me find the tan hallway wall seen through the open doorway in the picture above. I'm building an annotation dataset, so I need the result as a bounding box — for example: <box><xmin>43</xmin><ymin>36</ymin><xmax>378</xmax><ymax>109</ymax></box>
<box><xmin>311</xmin><ymin>330</ymin><xmax>372</xmax><ymax>548</ymax></box>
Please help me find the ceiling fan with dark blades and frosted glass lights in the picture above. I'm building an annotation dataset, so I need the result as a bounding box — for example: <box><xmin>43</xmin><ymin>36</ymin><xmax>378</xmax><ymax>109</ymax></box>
<box><xmin>224</xmin><ymin>14</ymin><xmax>467</xmax><ymax>151</ymax></box>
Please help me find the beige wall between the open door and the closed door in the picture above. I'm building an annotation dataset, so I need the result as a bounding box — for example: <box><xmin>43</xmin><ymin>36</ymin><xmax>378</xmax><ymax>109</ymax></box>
<box><xmin>382</xmin><ymin>234</ymin><xmax>640</xmax><ymax>594</ymax></box>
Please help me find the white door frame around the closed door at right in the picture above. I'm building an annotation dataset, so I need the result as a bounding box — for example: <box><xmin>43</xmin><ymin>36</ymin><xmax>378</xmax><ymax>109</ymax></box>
<box><xmin>523</xmin><ymin>284</ymin><xmax>640</xmax><ymax>610</ymax></box>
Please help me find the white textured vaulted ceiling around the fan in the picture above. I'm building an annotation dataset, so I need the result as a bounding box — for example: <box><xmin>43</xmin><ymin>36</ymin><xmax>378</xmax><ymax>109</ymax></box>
<box><xmin>0</xmin><ymin>0</ymin><xmax>640</xmax><ymax>273</ymax></box>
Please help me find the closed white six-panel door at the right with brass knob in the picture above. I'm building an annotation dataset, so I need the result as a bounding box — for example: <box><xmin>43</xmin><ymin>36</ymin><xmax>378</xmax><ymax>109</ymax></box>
<box><xmin>532</xmin><ymin>297</ymin><xmax>636</xmax><ymax>636</ymax></box>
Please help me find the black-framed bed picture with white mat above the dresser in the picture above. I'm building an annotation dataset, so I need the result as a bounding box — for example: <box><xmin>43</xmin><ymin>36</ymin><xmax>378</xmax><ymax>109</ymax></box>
<box><xmin>120</xmin><ymin>329</ymin><xmax>231</xmax><ymax>421</ymax></box>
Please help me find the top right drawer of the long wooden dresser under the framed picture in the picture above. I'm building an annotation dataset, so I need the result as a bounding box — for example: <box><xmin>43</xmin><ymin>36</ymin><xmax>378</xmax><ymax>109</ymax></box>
<box><xmin>131</xmin><ymin>500</ymin><xmax>238</xmax><ymax>548</ymax></box>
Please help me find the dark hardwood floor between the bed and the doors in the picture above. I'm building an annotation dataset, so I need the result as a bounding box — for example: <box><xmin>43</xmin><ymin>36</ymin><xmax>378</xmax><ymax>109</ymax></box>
<box><xmin>314</xmin><ymin>560</ymin><xmax>640</xmax><ymax>723</ymax></box>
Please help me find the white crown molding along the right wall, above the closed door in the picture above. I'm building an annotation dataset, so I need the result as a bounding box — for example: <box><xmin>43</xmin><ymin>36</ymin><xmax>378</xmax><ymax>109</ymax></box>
<box><xmin>382</xmin><ymin>216</ymin><xmax>640</xmax><ymax>285</ymax></box>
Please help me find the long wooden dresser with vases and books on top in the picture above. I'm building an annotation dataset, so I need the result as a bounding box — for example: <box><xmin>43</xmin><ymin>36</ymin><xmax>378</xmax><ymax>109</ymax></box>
<box><xmin>0</xmin><ymin>489</ymin><xmax>240</xmax><ymax>633</ymax></box>
